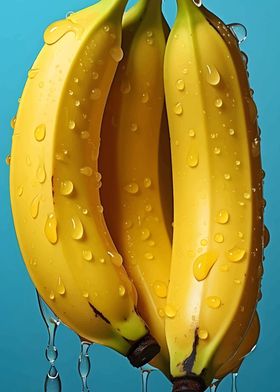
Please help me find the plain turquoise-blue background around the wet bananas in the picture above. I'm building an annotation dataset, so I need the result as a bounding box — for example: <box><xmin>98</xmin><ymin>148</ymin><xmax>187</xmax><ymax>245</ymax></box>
<box><xmin>0</xmin><ymin>0</ymin><xmax>280</xmax><ymax>392</ymax></box>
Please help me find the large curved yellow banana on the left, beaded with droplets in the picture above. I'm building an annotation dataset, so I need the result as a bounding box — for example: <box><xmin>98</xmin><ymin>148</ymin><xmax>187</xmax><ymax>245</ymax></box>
<box><xmin>10</xmin><ymin>0</ymin><xmax>159</xmax><ymax>366</ymax></box>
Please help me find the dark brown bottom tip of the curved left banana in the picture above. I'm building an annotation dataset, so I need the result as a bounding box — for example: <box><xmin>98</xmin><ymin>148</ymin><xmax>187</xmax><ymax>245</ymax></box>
<box><xmin>127</xmin><ymin>334</ymin><xmax>160</xmax><ymax>368</ymax></box>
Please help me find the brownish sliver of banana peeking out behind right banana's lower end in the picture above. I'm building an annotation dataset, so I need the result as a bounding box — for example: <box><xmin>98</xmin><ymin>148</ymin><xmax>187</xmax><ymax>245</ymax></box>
<box><xmin>215</xmin><ymin>312</ymin><xmax>260</xmax><ymax>379</ymax></box>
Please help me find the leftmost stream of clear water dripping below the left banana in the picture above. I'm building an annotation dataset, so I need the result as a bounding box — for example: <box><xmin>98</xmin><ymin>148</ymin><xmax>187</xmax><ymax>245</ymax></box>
<box><xmin>37</xmin><ymin>292</ymin><xmax>62</xmax><ymax>392</ymax></box>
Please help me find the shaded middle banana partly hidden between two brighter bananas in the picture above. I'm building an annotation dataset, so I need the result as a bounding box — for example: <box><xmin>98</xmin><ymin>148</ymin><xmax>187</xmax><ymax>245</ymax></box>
<box><xmin>100</xmin><ymin>0</ymin><xmax>172</xmax><ymax>374</ymax></box>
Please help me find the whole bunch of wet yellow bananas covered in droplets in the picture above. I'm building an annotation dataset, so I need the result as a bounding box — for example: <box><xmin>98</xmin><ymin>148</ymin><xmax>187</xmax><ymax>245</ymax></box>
<box><xmin>7</xmin><ymin>0</ymin><xmax>269</xmax><ymax>392</ymax></box>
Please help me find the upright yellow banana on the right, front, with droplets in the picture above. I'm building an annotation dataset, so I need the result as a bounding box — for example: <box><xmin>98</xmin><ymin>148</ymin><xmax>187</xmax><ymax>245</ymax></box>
<box><xmin>164</xmin><ymin>0</ymin><xmax>264</xmax><ymax>392</ymax></box>
